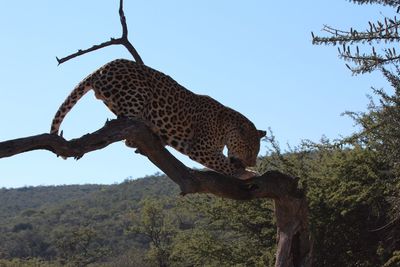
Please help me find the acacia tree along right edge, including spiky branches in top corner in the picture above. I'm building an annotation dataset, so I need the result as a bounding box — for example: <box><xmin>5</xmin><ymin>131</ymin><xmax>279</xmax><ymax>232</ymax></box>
<box><xmin>312</xmin><ymin>0</ymin><xmax>400</xmax><ymax>266</ymax></box>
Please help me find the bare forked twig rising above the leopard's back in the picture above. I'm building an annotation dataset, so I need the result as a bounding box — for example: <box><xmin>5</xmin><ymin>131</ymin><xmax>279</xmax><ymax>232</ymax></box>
<box><xmin>56</xmin><ymin>0</ymin><xmax>144</xmax><ymax>65</ymax></box>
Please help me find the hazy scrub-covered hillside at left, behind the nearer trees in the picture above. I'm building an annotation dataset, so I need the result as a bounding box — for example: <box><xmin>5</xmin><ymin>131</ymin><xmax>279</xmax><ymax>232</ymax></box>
<box><xmin>0</xmin><ymin>175</ymin><xmax>179</xmax><ymax>266</ymax></box>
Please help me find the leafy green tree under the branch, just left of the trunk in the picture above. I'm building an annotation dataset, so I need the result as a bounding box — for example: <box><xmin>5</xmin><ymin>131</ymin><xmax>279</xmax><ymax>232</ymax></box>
<box><xmin>171</xmin><ymin>196</ymin><xmax>275</xmax><ymax>266</ymax></box>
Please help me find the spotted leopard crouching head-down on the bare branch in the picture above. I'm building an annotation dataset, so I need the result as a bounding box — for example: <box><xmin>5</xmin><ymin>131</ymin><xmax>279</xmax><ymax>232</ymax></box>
<box><xmin>50</xmin><ymin>59</ymin><xmax>266</xmax><ymax>179</ymax></box>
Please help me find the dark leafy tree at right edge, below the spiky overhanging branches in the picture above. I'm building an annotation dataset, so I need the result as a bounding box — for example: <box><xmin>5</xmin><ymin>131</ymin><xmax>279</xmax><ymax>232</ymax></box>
<box><xmin>349</xmin><ymin>69</ymin><xmax>400</xmax><ymax>266</ymax></box>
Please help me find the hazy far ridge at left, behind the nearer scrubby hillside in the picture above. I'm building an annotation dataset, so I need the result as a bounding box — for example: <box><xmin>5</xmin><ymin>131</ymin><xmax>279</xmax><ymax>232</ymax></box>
<box><xmin>0</xmin><ymin>175</ymin><xmax>178</xmax><ymax>218</ymax></box>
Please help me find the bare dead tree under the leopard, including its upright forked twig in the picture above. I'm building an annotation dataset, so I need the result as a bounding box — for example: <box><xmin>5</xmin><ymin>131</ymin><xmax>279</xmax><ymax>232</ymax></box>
<box><xmin>0</xmin><ymin>0</ymin><xmax>312</xmax><ymax>267</ymax></box>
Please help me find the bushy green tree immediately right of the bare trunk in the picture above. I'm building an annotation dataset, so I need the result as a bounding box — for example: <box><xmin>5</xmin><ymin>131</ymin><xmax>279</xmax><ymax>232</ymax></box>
<box><xmin>261</xmin><ymin>131</ymin><xmax>393</xmax><ymax>267</ymax></box>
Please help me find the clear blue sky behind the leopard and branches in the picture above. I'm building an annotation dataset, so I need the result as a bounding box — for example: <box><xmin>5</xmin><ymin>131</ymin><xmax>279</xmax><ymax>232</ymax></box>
<box><xmin>0</xmin><ymin>0</ymin><xmax>392</xmax><ymax>187</ymax></box>
